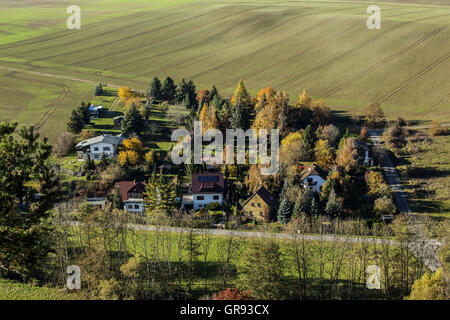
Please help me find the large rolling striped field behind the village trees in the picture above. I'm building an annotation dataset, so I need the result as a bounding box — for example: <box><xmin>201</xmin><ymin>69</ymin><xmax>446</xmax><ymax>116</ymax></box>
<box><xmin>0</xmin><ymin>0</ymin><xmax>450</xmax><ymax>139</ymax></box>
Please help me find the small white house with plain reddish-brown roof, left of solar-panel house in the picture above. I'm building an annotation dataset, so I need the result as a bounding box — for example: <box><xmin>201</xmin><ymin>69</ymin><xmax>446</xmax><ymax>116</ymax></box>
<box><xmin>116</xmin><ymin>181</ymin><xmax>145</xmax><ymax>214</ymax></box>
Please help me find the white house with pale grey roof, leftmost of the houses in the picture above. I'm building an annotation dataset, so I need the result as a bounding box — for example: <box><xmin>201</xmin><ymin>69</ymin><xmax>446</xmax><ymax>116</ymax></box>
<box><xmin>75</xmin><ymin>134</ymin><xmax>122</xmax><ymax>161</ymax></box>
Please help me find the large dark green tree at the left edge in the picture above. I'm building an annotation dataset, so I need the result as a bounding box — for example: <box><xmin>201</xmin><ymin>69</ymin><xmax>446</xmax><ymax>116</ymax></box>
<box><xmin>0</xmin><ymin>122</ymin><xmax>58</xmax><ymax>278</ymax></box>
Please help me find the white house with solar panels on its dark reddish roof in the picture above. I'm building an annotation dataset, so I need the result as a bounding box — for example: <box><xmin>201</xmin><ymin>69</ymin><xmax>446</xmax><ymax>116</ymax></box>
<box><xmin>181</xmin><ymin>173</ymin><xmax>225</xmax><ymax>210</ymax></box>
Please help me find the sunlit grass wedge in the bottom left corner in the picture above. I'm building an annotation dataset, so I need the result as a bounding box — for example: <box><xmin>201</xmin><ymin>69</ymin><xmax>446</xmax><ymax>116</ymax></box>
<box><xmin>0</xmin><ymin>279</ymin><xmax>80</xmax><ymax>300</ymax></box>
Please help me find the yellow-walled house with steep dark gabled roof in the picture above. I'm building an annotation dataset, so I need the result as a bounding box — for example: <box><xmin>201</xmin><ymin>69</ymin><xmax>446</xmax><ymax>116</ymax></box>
<box><xmin>242</xmin><ymin>187</ymin><xmax>278</xmax><ymax>221</ymax></box>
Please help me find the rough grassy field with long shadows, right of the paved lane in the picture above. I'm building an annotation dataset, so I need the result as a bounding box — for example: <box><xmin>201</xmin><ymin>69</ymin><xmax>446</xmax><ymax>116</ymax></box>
<box><xmin>397</xmin><ymin>131</ymin><xmax>450</xmax><ymax>218</ymax></box>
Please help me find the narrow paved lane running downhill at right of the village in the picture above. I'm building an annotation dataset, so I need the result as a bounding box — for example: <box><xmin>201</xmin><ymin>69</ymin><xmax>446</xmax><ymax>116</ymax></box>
<box><xmin>369</xmin><ymin>129</ymin><xmax>411</xmax><ymax>214</ymax></box>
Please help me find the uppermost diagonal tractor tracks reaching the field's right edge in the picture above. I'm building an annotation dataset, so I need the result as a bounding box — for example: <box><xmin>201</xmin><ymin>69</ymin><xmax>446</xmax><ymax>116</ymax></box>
<box><xmin>321</xmin><ymin>26</ymin><xmax>448</xmax><ymax>96</ymax></box>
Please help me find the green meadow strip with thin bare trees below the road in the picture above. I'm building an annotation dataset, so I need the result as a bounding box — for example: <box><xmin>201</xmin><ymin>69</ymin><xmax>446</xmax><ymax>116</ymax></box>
<box><xmin>53</xmin><ymin>207</ymin><xmax>436</xmax><ymax>299</ymax></box>
